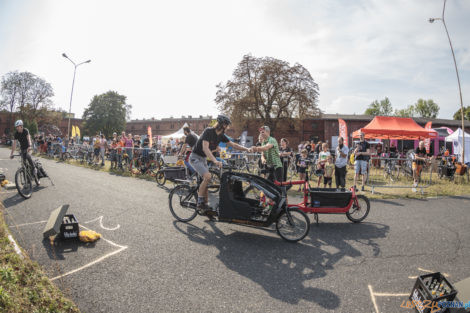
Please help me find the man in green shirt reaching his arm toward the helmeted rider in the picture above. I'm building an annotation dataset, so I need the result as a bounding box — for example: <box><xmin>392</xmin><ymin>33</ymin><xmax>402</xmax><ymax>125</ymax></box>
<box><xmin>252</xmin><ymin>126</ymin><xmax>283</xmax><ymax>182</ymax></box>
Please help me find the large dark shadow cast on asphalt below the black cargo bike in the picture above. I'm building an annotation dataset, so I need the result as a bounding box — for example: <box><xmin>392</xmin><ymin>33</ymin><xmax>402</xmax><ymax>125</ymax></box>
<box><xmin>173</xmin><ymin>221</ymin><xmax>389</xmax><ymax>310</ymax></box>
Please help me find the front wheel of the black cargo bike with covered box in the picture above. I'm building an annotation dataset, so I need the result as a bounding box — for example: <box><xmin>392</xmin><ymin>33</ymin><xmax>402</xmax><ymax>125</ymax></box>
<box><xmin>276</xmin><ymin>208</ymin><xmax>310</xmax><ymax>242</ymax></box>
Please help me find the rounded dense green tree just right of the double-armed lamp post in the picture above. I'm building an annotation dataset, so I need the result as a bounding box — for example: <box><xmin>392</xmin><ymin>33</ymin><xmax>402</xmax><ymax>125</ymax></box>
<box><xmin>83</xmin><ymin>91</ymin><xmax>132</xmax><ymax>137</ymax></box>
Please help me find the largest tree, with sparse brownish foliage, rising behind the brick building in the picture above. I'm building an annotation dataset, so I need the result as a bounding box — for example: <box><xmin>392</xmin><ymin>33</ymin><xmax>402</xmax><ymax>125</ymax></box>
<box><xmin>215</xmin><ymin>55</ymin><xmax>320</xmax><ymax>131</ymax></box>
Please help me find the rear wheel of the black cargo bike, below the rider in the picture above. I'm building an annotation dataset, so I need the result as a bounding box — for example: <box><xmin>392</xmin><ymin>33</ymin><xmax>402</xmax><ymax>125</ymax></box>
<box><xmin>168</xmin><ymin>185</ymin><xmax>197</xmax><ymax>223</ymax></box>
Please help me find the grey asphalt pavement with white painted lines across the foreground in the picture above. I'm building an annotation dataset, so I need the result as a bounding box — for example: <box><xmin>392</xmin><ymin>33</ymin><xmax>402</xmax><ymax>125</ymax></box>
<box><xmin>0</xmin><ymin>148</ymin><xmax>470</xmax><ymax>313</ymax></box>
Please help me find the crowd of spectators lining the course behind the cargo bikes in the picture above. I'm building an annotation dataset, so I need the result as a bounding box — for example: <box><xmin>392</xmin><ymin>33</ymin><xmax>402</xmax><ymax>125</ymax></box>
<box><xmin>20</xmin><ymin>116</ymin><xmax>438</xmax><ymax>191</ymax></box>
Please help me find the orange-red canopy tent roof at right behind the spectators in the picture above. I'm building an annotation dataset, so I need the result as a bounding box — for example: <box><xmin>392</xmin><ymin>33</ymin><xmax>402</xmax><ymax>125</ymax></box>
<box><xmin>352</xmin><ymin>116</ymin><xmax>437</xmax><ymax>140</ymax></box>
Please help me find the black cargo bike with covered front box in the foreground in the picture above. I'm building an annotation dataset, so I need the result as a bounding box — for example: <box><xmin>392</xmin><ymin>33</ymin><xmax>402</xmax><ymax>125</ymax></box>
<box><xmin>168</xmin><ymin>168</ymin><xmax>310</xmax><ymax>242</ymax></box>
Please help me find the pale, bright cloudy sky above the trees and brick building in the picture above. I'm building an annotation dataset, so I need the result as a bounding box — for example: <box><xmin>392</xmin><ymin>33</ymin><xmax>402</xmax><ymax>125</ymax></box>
<box><xmin>0</xmin><ymin>0</ymin><xmax>470</xmax><ymax>119</ymax></box>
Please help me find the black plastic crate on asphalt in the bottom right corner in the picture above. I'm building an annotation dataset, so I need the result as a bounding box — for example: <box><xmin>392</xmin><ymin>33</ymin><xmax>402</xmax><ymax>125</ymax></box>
<box><xmin>410</xmin><ymin>272</ymin><xmax>457</xmax><ymax>313</ymax></box>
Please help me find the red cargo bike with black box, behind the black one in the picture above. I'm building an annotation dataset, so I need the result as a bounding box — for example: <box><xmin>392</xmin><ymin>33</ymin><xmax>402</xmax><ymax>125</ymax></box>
<box><xmin>275</xmin><ymin>170</ymin><xmax>370</xmax><ymax>223</ymax></box>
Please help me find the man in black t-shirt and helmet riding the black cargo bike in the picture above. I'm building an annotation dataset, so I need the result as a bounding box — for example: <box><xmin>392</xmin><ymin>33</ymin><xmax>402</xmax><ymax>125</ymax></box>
<box><xmin>189</xmin><ymin>114</ymin><xmax>249</xmax><ymax>216</ymax></box>
